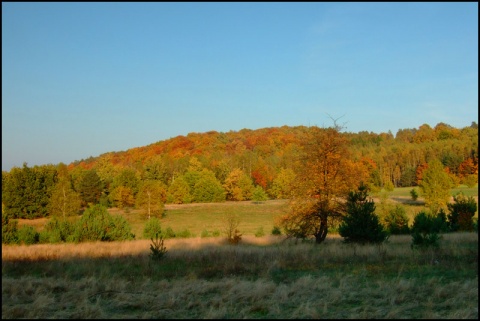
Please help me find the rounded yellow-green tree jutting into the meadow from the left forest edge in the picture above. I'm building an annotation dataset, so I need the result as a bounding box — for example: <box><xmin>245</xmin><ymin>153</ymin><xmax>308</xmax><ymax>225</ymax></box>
<box><xmin>136</xmin><ymin>180</ymin><xmax>167</xmax><ymax>219</ymax></box>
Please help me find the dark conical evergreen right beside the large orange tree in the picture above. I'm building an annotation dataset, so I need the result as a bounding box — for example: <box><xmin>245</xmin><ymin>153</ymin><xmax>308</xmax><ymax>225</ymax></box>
<box><xmin>338</xmin><ymin>184</ymin><xmax>388</xmax><ymax>244</ymax></box>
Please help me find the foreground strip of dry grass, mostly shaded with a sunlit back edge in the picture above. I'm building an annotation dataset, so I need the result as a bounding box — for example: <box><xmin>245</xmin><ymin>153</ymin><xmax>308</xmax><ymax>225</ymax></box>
<box><xmin>2</xmin><ymin>233</ymin><xmax>478</xmax><ymax>319</ymax></box>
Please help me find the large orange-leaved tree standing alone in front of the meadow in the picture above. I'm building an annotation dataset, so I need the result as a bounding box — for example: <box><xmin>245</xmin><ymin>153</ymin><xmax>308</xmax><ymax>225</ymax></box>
<box><xmin>279</xmin><ymin>126</ymin><xmax>368</xmax><ymax>244</ymax></box>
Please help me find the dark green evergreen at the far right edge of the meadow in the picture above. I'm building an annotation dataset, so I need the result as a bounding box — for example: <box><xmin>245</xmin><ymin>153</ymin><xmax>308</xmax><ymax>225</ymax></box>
<box><xmin>447</xmin><ymin>193</ymin><xmax>477</xmax><ymax>231</ymax></box>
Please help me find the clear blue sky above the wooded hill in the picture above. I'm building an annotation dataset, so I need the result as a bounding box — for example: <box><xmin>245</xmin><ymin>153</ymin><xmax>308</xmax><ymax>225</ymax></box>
<box><xmin>2</xmin><ymin>2</ymin><xmax>478</xmax><ymax>171</ymax></box>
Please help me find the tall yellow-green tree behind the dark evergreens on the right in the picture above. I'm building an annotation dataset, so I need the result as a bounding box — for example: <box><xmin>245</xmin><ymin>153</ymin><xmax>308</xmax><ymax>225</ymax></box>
<box><xmin>419</xmin><ymin>159</ymin><xmax>452</xmax><ymax>213</ymax></box>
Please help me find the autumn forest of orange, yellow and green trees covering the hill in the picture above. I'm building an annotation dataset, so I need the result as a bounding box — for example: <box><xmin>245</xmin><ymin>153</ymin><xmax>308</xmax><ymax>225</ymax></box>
<box><xmin>2</xmin><ymin>122</ymin><xmax>478</xmax><ymax>219</ymax></box>
